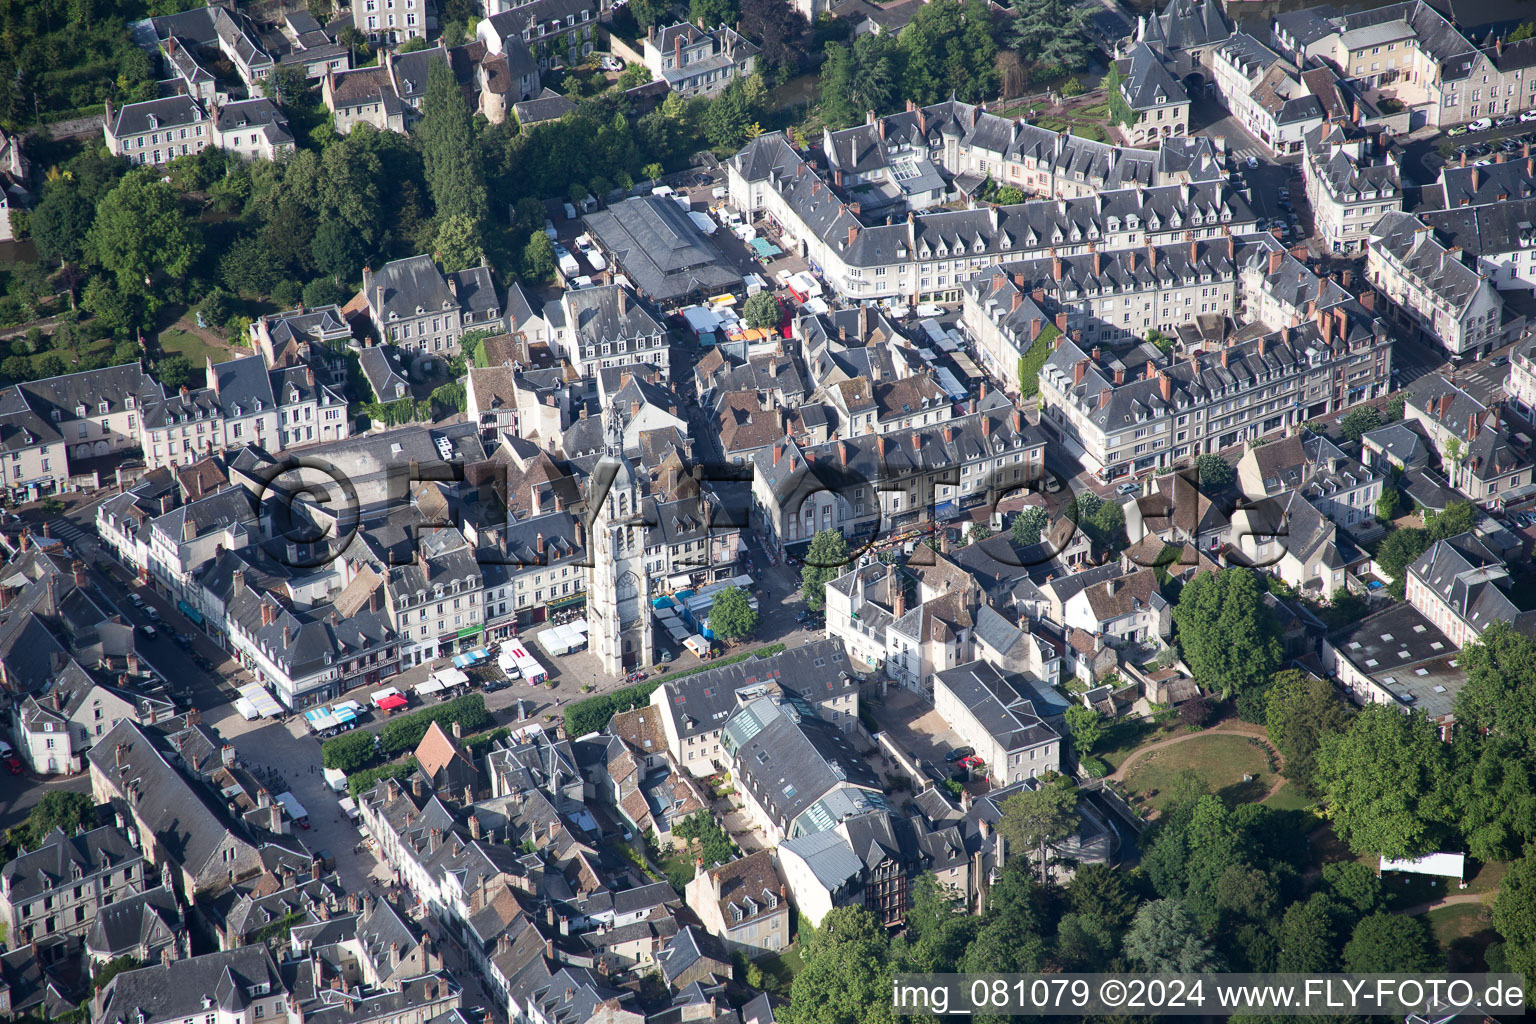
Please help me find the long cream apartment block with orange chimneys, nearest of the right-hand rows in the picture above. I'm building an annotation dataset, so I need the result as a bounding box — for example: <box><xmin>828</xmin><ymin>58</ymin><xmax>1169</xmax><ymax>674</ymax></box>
<box><xmin>1040</xmin><ymin>304</ymin><xmax>1392</xmax><ymax>481</ymax></box>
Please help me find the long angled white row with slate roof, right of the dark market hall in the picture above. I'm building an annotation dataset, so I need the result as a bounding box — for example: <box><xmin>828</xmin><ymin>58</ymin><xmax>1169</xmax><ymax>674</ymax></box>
<box><xmin>727</xmin><ymin>132</ymin><xmax>1256</xmax><ymax>301</ymax></box>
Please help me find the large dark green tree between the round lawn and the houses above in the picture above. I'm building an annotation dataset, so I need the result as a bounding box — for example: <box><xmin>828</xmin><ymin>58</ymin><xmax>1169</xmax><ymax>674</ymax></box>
<box><xmin>1174</xmin><ymin>567</ymin><xmax>1283</xmax><ymax>697</ymax></box>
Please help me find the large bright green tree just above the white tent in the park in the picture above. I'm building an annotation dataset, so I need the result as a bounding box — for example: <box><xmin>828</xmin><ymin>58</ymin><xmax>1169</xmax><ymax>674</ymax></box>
<box><xmin>1313</xmin><ymin>703</ymin><xmax>1452</xmax><ymax>857</ymax></box>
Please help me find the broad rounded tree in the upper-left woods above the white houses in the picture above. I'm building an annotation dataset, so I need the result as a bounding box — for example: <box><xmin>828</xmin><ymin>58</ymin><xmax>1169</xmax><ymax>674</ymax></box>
<box><xmin>86</xmin><ymin>172</ymin><xmax>203</xmax><ymax>295</ymax></box>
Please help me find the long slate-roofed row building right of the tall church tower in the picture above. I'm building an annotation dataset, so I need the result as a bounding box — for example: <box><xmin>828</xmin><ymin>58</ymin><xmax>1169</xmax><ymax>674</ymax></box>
<box><xmin>753</xmin><ymin>393</ymin><xmax>1046</xmax><ymax>551</ymax></box>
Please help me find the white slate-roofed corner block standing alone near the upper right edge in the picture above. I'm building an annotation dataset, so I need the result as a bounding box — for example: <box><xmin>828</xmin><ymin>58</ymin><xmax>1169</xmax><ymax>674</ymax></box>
<box><xmin>1301</xmin><ymin>124</ymin><xmax>1402</xmax><ymax>253</ymax></box>
